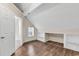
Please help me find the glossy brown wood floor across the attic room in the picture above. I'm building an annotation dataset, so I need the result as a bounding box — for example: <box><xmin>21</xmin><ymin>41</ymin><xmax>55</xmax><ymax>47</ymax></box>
<box><xmin>15</xmin><ymin>41</ymin><xmax>79</xmax><ymax>56</ymax></box>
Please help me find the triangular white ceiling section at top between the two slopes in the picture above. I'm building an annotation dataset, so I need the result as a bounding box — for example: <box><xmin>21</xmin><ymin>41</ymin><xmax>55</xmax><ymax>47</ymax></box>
<box><xmin>15</xmin><ymin>3</ymin><xmax>42</xmax><ymax>15</ymax></box>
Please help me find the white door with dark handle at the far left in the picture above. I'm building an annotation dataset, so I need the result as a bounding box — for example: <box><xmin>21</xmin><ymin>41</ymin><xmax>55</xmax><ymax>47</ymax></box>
<box><xmin>0</xmin><ymin>14</ymin><xmax>15</xmax><ymax>56</ymax></box>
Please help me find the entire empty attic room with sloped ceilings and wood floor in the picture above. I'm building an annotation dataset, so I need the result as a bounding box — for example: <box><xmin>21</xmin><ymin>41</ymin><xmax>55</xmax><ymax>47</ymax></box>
<box><xmin>0</xmin><ymin>3</ymin><xmax>79</xmax><ymax>56</ymax></box>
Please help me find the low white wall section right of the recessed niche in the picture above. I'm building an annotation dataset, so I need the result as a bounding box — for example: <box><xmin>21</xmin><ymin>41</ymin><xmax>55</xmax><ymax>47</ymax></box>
<box><xmin>64</xmin><ymin>34</ymin><xmax>79</xmax><ymax>51</ymax></box>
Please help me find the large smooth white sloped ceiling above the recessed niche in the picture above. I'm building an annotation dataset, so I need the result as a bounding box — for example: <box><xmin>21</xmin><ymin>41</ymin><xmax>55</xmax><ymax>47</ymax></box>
<box><xmin>15</xmin><ymin>3</ymin><xmax>79</xmax><ymax>34</ymax></box>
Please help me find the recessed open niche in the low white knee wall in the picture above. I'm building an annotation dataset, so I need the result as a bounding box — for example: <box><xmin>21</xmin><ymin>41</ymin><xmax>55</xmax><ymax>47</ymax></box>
<box><xmin>46</xmin><ymin>33</ymin><xmax>64</xmax><ymax>43</ymax></box>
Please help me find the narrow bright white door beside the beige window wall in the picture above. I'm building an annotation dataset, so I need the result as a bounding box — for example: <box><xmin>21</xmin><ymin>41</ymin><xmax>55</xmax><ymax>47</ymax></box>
<box><xmin>15</xmin><ymin>16</ymin><xmax>22</xmax><ymax>50</ymax></box>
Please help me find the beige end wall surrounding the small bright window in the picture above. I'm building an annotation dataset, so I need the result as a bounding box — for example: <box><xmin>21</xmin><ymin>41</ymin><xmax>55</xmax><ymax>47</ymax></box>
<box><xmin>23</xmin><ymin>18</ymin><xmax>37</xmax><ymax>42</ymax></box>
